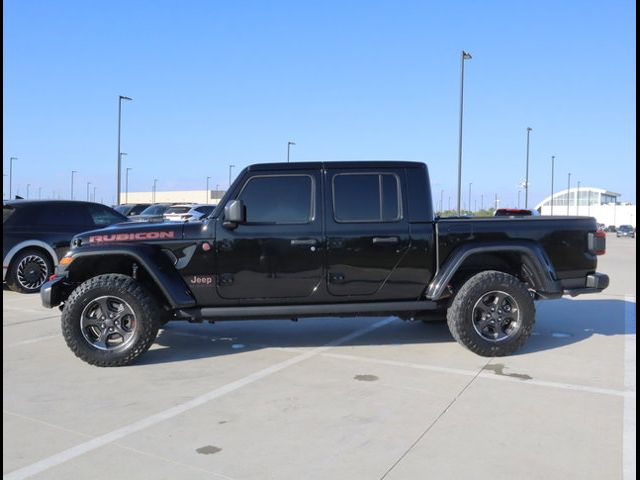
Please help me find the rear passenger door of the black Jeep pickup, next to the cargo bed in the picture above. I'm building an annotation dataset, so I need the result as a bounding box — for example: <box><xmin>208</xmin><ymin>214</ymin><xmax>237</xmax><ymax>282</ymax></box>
<box><xmin>325</xmin><ymin>167</ymin><xmax>410</xmax><ymax>299</ymax></box>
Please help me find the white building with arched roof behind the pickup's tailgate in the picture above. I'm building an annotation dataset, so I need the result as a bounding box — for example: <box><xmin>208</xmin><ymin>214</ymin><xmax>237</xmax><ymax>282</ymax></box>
<box><xmin>536</xmin><ymin>187</ymin><xmax>636</xmax><ymax>227</ymax></box>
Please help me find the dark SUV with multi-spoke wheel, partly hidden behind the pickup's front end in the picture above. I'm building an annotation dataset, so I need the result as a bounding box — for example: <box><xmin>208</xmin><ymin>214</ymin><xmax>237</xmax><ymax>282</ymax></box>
<box><xmin>2</xmin><ymin>200</ymin><xmax>127</xmax><ymax>293</ymax></box>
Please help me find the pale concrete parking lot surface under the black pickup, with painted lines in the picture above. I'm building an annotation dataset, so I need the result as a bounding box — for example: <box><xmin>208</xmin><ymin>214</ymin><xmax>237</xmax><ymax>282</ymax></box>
<box><xmin>3</xmin><ymin>236</ymin><xmax>636</xmax><ymax>480</ymax></box>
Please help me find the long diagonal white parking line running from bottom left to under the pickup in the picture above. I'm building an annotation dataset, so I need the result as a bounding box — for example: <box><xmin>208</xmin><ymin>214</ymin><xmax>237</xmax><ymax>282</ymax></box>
<box><xmin>3</xmin><ymin>317</ymin><xmax>395</xmax><ymax>480</ymax></box>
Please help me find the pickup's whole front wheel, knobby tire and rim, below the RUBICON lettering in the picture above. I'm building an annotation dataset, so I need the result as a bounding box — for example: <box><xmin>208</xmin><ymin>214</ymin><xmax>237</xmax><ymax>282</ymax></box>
<box><xmin>62</xmin><ymin>274</ymin><xmax>163</xmax><ymax>367</ymax></box>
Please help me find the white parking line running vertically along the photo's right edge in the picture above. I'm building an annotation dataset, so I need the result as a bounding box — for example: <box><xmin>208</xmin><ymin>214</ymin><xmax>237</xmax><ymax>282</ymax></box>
<box><xmin>622</xmin><ymin>295</ymin><xmax>636</xmax><ymax>480</ymax></box>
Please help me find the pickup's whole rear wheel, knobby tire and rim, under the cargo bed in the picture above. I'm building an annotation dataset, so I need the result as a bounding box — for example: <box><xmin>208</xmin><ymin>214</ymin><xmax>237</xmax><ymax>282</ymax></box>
<box><xmin>447</xmin><ymin>271</ymin><xmax>535</xmax><ymax>357</ymax></box>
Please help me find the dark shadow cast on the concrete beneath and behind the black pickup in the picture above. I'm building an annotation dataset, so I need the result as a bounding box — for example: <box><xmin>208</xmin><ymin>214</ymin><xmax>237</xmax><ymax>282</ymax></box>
<box><xmin>136</xmin><ymin>299</ymin><xmax>635</xmax><ymax>365</ymax></box>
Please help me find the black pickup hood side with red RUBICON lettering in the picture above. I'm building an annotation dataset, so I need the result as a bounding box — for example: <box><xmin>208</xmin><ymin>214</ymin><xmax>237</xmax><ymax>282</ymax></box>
<box><xmin>71</xmin><ymin>222</ymin><xmax>184</xmax><ymax>247</ymax></box>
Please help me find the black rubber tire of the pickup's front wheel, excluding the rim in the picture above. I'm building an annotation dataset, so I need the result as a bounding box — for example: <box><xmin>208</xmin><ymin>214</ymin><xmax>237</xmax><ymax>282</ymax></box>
<box><xmin>61</xmin><ymin>274</ymin><xmax>164</xmax><ymax>367</ymax></box>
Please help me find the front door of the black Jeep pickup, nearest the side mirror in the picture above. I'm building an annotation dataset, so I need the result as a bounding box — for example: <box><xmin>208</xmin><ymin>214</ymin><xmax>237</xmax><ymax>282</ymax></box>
<box><xmin>216</xmin><ymin>169</ymin><xmax>323</xmax><ymax>302</ymax></box>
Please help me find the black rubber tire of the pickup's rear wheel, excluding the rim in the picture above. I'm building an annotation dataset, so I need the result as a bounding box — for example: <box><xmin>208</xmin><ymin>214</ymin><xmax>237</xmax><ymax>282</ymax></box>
<box><xmin>447</xmin><ymin>270</ymin><xmax>536</xmax><ymax>357</ymax></box>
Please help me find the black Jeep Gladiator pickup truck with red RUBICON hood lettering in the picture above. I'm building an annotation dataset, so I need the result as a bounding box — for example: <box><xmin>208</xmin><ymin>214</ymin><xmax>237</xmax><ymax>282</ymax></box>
<box><xmin>41</xmin><ymin>162</ymin><xmax>609</xmax><ymax>366</ymax></box>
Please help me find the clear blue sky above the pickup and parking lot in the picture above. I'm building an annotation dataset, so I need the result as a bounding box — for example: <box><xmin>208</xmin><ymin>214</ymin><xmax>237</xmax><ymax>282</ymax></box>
<box><xmin>3</xmin><ymin>0</ymin><xmax>636</xmax><ymax>206</ymax></box>
